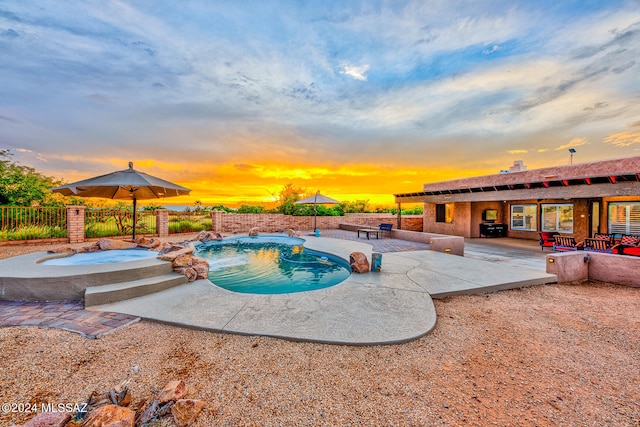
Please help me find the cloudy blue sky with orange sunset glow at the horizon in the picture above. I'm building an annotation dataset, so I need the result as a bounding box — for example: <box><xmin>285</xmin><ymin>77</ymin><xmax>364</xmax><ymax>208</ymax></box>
<box><xmin>0</xmin><ymin>0</ymin><xmax>640</xmax><ymax>206</ymax></box>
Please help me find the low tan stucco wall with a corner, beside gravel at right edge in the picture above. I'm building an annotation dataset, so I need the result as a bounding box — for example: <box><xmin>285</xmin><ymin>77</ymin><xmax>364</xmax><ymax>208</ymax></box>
<box><xmin>547</xmin><ymin>251</ymin><xmax>640</xmax><ymax>288</ymax></box>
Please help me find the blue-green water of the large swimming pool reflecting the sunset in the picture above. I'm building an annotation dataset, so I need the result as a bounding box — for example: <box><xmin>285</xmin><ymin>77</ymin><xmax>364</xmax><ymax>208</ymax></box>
<box><xmin>194</xmin><ymin>236</ymin><xmax>351</xmax><ymax>294</ymax></box>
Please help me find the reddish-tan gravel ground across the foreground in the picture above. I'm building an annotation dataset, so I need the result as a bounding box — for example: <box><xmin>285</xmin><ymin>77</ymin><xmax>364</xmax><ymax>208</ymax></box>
<box><xmin>0</xmin><ymin>239</ymin><xmax>640</xmax><ymax>426</ymax></box>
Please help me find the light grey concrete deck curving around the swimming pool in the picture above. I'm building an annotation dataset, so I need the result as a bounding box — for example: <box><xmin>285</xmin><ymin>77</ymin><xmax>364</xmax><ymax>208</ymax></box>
<box><xmin>91</xmin><ymin>236</ymin><xmax>556</xmax><ymax>345</ymax></box>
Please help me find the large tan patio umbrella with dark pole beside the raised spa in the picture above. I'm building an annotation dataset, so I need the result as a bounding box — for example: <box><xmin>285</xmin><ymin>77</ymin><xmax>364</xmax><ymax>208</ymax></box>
<box><xmin>51</xmin><ymin>162</ymin><xmax>191</xmax><ymax>240</ymax></box>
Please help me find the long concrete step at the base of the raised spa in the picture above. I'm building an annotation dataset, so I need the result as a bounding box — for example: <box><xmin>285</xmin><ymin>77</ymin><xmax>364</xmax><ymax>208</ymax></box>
<box><xmin>84</xmin><ymin>273</ymin><xmax>188</xmax><ymax>307</ymax></box>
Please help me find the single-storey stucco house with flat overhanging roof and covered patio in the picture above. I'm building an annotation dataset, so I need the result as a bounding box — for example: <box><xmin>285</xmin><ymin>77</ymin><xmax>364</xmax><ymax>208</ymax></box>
<box><xmin>394</xmin><ymin>156</ymin><xmax>640</xmax><ymax>241</ymax></box>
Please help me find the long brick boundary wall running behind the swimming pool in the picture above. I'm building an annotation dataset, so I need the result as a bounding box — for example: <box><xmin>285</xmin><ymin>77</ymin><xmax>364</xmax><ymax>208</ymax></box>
<box><xmin>211</xmin><ymin>211</ymin><xmax>422</xmax><ymax>233</ymax></box>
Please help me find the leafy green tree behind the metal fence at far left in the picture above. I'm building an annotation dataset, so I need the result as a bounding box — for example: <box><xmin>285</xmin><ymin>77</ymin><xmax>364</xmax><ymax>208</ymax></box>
<box><xmin>0</xmin><ymin>149</ymin><xmax>64</xmax><ymax>206</ymax></box>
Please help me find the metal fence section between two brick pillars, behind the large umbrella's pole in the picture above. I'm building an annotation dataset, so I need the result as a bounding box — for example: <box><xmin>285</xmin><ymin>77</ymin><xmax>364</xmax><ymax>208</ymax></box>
<box><xmin>84</xmin><ymin>209</ymin><xmax>156</xmax><ymax>239</ymax></box>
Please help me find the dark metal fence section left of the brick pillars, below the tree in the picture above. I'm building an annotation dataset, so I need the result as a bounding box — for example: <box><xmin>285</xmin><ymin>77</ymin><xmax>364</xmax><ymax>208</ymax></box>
<box><xmin>0</xmin><ymin>206</ymin><xmax>67</xmax><ymax>241</ymax></box>
